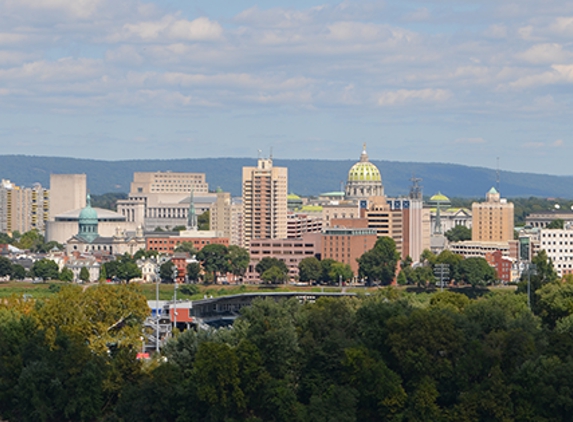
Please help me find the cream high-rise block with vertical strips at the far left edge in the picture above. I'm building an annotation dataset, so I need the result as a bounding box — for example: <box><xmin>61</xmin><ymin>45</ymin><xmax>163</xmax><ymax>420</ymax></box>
<box><xmin>0</xmin><ymin>180</ymin><xmax>49</xmax><ymax>233</ymax></box>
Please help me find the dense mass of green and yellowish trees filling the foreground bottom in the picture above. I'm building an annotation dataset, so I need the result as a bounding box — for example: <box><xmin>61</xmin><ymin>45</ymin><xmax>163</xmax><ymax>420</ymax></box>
<box><xmin>5</xmin><ymin>274</ymin><xmax>573</xmax><ymax>422</ymax></box>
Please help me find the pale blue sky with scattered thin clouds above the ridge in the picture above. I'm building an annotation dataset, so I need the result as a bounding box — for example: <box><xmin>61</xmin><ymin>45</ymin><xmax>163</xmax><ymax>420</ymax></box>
<box><xmin>0</xmin><ymin>0</ymin><xmax>573</xmax><ymax>175</ymax></box>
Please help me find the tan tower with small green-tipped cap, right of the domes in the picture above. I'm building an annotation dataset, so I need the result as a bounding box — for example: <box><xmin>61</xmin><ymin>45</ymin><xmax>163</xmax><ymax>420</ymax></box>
<box><xmin>472</xmin><ymin>188</ymin><xmax>514</xmax><ymax>242</ymax></box>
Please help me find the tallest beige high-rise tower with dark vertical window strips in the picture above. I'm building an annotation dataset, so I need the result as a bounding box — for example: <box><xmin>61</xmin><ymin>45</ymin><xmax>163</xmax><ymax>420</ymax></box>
<box><xmin>243</xmin><ymin>158</ymin><xmax>288</xmax><ymax>247</ymax></box>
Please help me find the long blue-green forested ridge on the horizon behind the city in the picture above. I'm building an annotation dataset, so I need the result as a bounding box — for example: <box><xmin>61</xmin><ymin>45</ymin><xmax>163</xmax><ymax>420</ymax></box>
<box><xmin>0</xmin><ymin>155</ymin><xmax>573</xmax><ymax>198</ymax></box>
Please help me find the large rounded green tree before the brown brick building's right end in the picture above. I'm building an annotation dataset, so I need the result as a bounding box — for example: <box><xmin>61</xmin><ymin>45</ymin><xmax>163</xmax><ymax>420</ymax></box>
<box><xmin>358</xmin><ymin>237</ymin><xmax>400</xmax><ymax>285</ymax></box>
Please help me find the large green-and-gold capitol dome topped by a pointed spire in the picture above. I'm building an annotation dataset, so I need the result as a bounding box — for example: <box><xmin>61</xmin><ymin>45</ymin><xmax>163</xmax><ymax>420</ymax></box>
<box><xmin>345</xmin><ymin>144</ymin><xmax>384</xmax><ymax>200</ymax></box>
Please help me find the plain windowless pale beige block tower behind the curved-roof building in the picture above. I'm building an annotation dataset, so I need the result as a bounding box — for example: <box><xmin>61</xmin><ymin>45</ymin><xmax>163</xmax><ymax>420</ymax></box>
<box><xmin>50</xmin><ymin>174</ymin><xmax>87</xmax><ymax>221</ymax></box>
